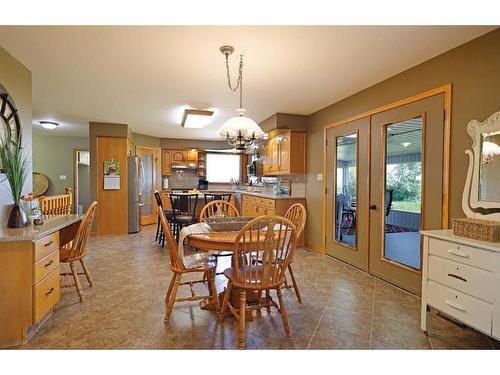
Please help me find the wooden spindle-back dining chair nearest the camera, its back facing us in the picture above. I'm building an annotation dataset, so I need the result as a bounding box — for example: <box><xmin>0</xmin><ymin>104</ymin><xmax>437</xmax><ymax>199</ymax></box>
<box><xmin>219</xmin><ymin>216</ymin><xmax>297</xmax><ymax>349</ymax></box>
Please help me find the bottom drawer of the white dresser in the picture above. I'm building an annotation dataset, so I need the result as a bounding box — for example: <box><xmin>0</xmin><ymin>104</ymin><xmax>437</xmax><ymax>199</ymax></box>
<box><xmin>427</xmin><ymin>281</ymin><xmax>493</xmax><ymax>335</ymax></box>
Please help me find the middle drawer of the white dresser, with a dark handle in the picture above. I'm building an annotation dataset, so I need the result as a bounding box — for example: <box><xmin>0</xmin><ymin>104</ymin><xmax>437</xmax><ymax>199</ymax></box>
<box><xmin>428</xmin><ymin>255</ymin><xmax>495</xmax><ymax>302</ymax></box>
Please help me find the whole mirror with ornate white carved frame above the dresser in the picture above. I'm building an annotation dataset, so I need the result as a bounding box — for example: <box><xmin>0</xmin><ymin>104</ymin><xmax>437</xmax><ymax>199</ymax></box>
<box><xmin>462</xmin><ymin>111</ymin><xmax>500</xmax><ymax>221</ymax></box>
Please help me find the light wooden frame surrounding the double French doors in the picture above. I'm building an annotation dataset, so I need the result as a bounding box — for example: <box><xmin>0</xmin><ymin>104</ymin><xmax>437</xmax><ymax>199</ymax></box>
<box><xmin>321</xmin><ymin>83</ymin><xmax>452</xmax><ymax>255</ymax></box>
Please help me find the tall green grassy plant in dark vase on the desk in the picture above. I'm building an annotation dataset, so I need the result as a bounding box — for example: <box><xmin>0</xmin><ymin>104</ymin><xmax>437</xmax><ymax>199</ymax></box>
<box><xmin>0</xmin><ymin>140</ymin><xmax>29</xmax><ymax>228</ymax></box>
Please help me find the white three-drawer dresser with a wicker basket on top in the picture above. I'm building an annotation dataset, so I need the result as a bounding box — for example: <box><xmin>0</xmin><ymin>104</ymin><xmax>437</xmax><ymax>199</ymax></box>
<box><xmin>421</xmin><ymin>230</ymin><xmax>500</xmax><ymax>339</ymax></box>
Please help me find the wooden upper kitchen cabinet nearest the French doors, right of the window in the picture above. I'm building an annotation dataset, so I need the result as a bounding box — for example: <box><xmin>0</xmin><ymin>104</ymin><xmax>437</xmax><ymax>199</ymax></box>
<box><xmin>263</xmin><ymin>130</ymin><xmax>306</xmax><ymax>176</ymax></box>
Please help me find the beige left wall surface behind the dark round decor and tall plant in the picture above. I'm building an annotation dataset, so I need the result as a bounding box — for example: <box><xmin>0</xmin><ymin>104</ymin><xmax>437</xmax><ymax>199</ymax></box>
<box><xmin>0</xmin><ymin>47</ymin><xmax>33</xmax><ymax>225</ymax></box>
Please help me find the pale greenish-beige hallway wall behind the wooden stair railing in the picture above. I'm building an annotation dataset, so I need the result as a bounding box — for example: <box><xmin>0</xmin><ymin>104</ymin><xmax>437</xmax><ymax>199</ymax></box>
<box><xmin>33</xmin><ymin>133</ymin><xmax>90</xmax><ymax>195</ymax></box>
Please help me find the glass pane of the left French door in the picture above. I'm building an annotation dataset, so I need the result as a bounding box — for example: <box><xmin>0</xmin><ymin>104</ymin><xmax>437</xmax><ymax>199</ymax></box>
<box><xmin>334</xmin><ymin>133</ymin><xmax>358</xmax><ymax>247</ymax></box>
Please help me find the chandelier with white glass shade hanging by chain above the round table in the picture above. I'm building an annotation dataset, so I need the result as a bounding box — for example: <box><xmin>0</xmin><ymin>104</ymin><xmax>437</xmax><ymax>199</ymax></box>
<box><xmin>217</xmin><ymin>46</ymin><xmax>265</xmax><ymax>150</ymax></box>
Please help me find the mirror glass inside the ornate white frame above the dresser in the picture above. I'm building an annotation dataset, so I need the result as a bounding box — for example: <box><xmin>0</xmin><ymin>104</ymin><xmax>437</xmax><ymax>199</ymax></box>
<box><xmin>479</xmin><ymin>130</ymin><xmax>500</xmax><ymax>202</ymax></box>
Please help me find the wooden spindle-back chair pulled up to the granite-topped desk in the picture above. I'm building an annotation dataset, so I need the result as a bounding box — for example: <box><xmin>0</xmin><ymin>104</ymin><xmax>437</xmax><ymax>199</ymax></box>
<box><xmin>59</xmin><ymin>201</ymin><xmax>97</xmax><ymax>302</ymax></box>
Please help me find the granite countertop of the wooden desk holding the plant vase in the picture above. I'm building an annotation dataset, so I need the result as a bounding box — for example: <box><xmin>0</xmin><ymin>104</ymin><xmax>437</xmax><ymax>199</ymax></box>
<box><xmin>0</xmin><ymin>214</ymin><xmax>84</xmax><ymax>242</ymax></box>
